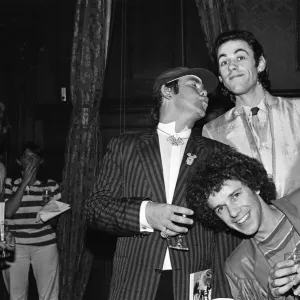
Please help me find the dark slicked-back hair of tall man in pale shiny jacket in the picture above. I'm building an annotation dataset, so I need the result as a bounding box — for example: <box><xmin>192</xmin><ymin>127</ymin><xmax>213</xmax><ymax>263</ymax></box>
<box><xmin>212</xmin><ymin>30</ymin><xmax>270</xmax><ymax>102</ymax></box>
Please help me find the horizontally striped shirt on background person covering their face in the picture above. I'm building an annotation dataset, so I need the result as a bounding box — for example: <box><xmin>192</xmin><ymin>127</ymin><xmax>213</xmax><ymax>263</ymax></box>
<box><xmin>4</xmin><ymin>178</ymin><xmax>61</xmax><ymax>246</ymax></box>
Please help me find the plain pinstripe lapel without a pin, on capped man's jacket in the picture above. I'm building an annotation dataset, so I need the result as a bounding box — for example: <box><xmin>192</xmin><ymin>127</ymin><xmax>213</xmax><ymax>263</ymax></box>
<box><xmin>137</xmin><ymin>130</ymin><xmax>167</xmax><ymax>203</ymax></box>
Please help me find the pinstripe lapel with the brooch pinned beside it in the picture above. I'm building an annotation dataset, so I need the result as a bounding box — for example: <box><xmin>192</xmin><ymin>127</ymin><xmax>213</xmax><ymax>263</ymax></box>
<box><xmin>172</xmin><ymin>133</ymin><xmax>200</xmax><ymax>206</ymax></box>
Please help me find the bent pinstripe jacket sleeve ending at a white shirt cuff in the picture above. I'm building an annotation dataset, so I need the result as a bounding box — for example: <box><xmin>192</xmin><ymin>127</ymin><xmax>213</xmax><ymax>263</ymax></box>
<box><xmin>85</xmin><ymin>137</ymin><xmax>147</xmax><ymax>236</ymax></box>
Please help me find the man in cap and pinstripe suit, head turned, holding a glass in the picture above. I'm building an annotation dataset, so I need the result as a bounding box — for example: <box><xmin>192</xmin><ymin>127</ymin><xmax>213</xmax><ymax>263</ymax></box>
<box><xmin>85</xmin><ymin>67</ymin><xmax>234</xmax><ymax>300</ymax></box>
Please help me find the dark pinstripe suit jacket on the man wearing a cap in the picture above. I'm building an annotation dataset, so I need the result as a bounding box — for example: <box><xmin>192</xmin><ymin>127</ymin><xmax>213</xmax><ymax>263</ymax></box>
<box><xmin>85</xmin><ymin>130</ymin><xmax>231</xmax><ymax>300</ymax></box>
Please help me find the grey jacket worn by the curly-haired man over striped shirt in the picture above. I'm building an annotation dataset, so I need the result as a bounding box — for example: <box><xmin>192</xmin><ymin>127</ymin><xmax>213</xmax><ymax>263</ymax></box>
<box><xmin>225</xmin><ymin>189</ymin><xmax>300</xmax><ymax>300</ymax></box>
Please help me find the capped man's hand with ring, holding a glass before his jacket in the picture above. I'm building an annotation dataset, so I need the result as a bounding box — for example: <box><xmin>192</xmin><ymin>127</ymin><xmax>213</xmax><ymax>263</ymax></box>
<box><xmin>146</xmin><ymin>202</ymin><xmax>194</xmax><ymax>236</ymax></box>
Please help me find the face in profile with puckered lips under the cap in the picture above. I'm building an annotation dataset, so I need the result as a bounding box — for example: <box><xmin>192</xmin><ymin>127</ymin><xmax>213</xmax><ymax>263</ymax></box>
<box><xmin>173</xmin><ymin>75</ymin><xmax>208</xmax><ymax>120</ymax></box>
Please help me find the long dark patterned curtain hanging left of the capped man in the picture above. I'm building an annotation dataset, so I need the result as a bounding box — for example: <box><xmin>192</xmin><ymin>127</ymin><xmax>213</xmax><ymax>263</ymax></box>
<box><xmin>58</xmin><ymin>0</ymin><xmax>111</xmax><ymax>300</ymax></box>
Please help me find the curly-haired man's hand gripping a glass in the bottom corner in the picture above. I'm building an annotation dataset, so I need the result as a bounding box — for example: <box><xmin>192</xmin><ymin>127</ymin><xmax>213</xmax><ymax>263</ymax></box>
<box><xmin>268</xmin><ymin>260</ymin><xmax>300</xmax><ymax>299</ymax></box>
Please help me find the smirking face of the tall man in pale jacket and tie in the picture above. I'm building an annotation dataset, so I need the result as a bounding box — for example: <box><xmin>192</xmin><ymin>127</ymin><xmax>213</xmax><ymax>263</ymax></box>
<box><xmin>218</xmin><ymin>40</ymin><xmax>266</xmax><ymax>95</ymax></box>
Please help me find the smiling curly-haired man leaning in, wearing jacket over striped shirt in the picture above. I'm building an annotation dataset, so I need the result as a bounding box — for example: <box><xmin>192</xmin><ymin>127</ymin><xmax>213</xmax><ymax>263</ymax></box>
<box><xmin>187</xmin><ymin>149</ymin><xmax>300</xmax><ymax>300</ymax></box>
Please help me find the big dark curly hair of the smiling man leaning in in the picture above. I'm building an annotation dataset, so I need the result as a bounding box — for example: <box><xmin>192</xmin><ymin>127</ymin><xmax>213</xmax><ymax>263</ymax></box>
<box><xmin>186</xmin><ymin>148</ymin><xmax>276</xmax><ymax>230</ymax></box>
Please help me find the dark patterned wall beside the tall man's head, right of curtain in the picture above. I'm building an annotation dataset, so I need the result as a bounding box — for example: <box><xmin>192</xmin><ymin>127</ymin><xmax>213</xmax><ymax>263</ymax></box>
<box><xmin>235</xmin><ymin>0</ymin><xmax>300</xmax><ymax>90</ymax></box>
